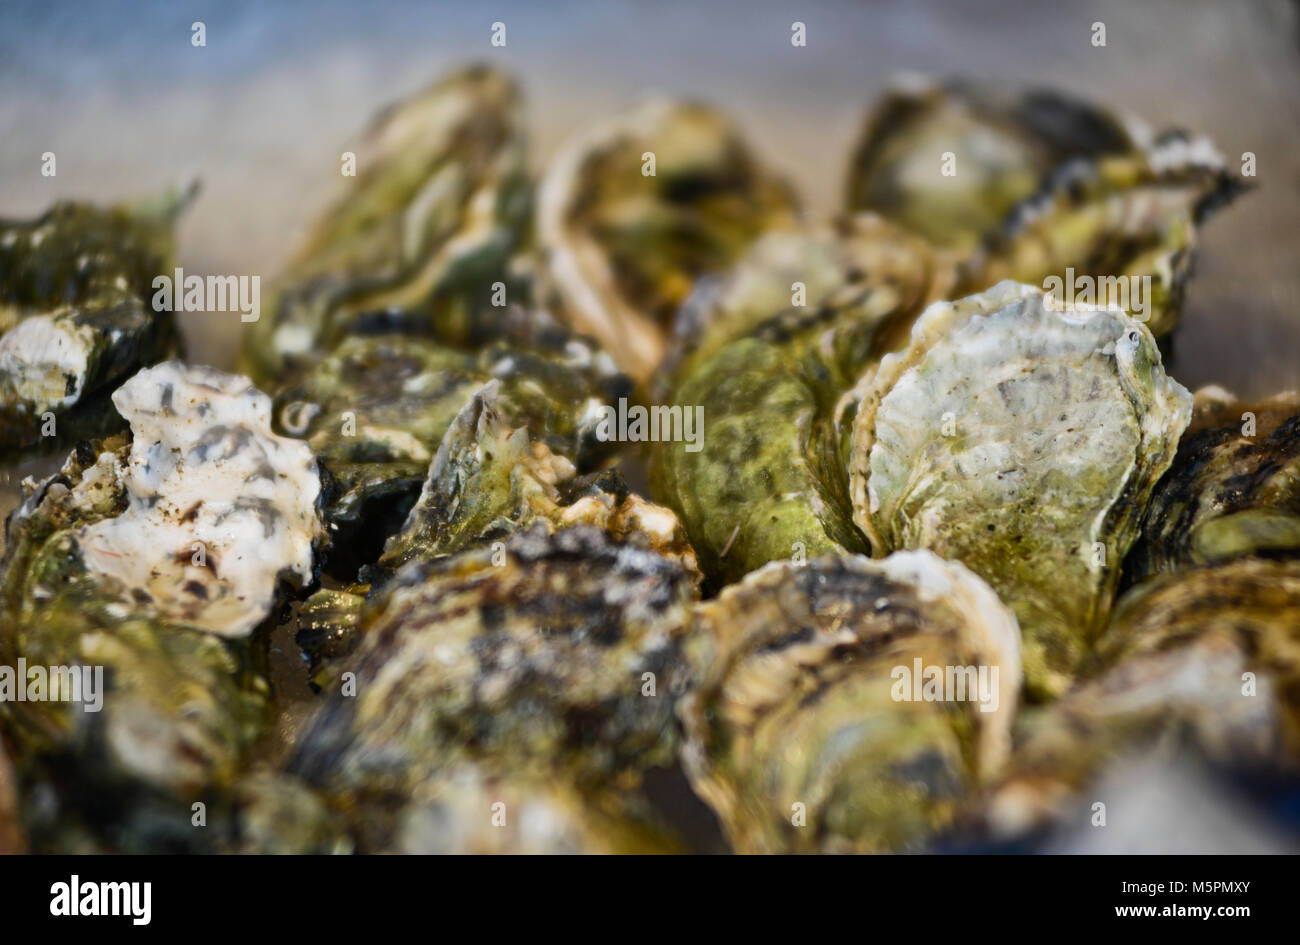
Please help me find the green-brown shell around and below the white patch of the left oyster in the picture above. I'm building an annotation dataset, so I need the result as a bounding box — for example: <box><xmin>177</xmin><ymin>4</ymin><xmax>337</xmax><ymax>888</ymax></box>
<box><xmin>0</xmin><ymin>437</ymin><xmax>270</xmax><ymax>851</ymax></box>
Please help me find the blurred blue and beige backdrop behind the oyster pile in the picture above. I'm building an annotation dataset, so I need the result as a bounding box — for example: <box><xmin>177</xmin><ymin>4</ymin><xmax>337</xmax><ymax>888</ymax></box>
<box><xmin>0</xmin><ymin>0</ymin><xmax>1300</xmax><ymax>396</ymax></box>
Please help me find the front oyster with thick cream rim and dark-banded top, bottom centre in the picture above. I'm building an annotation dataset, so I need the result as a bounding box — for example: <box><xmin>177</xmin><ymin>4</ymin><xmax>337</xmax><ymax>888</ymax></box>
<box><xmin>681</xmin><ymin>551</ymin><xmax>1021</xmax><ymax>853</ymax></box>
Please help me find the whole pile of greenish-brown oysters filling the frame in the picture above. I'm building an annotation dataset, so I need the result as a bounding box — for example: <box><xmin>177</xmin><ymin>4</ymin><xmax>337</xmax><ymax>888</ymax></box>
<box><xmin>0</xmin><ymin>68</ymin><xmax>1300</xmax><ymax>851</ymax></box>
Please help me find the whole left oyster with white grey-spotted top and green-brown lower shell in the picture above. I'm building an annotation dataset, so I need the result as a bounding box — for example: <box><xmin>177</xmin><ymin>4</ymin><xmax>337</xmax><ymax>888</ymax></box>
<box><xmin>0</xmin><ymin>361</ymin><xmax>322</xmax><ymax>849</ymax></box>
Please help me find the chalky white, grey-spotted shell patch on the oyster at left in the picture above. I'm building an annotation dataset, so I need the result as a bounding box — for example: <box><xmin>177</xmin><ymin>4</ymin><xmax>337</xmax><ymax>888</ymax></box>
<box><xmin>73</xmin><ymin>361</ymin><xmax>324</xmax><ymax>637</ymax></box>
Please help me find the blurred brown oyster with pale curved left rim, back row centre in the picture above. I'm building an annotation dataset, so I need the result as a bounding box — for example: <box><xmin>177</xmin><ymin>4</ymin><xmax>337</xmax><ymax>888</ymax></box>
<box><xmin>537</xmin><ymin>100</ymin><xmax>794</xmax><ymax>382</ymax></box>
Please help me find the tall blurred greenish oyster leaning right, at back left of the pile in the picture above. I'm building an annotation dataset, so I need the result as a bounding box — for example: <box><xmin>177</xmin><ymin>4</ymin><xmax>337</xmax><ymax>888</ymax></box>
<box><xmin>241</xmin><ymin>66</ymin><xmax>530</xmax><ymax>381</ymax></box>
